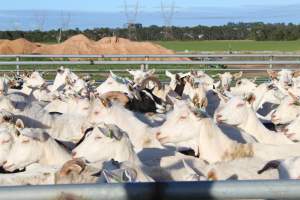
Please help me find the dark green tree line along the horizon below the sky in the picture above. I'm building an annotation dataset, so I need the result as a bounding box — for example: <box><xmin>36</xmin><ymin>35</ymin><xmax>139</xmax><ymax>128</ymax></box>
<box><xmin>0</xmin><ymin>22</ymin><xmax>300</xmax><ymax>43</ymax></box>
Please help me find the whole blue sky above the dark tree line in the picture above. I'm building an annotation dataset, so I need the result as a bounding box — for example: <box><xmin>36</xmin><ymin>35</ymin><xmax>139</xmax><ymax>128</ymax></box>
<box><xmin>0</xmin><ymin>0</ymin><xmax>300</xmax><ymax>30</ymax></box>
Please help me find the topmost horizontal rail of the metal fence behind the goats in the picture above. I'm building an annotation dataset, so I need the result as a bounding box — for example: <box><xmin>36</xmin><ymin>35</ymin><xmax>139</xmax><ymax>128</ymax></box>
<box><xmin>0</xmin><ymin>54</ymin><xmax>300</xmax><ymax>58</ymax></box>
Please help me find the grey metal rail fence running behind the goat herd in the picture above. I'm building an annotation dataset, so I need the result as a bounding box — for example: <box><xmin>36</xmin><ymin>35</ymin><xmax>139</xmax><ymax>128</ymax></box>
<box><xmin>0</xmin><ymin>54</ymin><xmax>300</xmax><ymax>73</ymax></box>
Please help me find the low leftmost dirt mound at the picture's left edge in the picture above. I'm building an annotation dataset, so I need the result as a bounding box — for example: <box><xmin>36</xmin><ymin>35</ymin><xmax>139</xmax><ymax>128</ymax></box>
<box><xmin>0</xmin><ymin>38</ymin><xmax>38</xmax><ymax>54</ymax></box>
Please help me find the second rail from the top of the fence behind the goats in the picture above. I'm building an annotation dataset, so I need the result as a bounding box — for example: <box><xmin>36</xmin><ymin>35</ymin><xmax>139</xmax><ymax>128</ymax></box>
<box><xmin>0</xmin><ymin>60</ymin><xmax>300</xmax><ymax>65</ymax></box>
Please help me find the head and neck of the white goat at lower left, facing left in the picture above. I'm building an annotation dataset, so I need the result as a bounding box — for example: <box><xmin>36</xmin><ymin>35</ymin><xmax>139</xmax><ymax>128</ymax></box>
<box><xmin>3</xmin><ymin>121</ymin><xmax>71</xmax><ymax>171</ymax></box>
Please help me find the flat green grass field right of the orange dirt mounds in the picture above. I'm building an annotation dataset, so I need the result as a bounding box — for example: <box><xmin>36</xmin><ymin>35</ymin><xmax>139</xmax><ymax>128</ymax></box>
<box><xmin>157</xmin><ymin>40</ymin><xmax>300</xmax><ymax>51</ymax></box>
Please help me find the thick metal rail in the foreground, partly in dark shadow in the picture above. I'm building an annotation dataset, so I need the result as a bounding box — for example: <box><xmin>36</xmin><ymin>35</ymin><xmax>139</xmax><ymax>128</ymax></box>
<box><xmin>0</xmin><ymin>180</ymin><xmax>300</xmax><ymax>200</ymax></box>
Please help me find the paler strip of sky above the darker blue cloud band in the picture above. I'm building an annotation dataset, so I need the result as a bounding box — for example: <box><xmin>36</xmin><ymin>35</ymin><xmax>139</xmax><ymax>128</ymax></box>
<box><xmin>1</xmin><ymin>0</ymin><xmax>300</xmax><ymax>12</ymax></box>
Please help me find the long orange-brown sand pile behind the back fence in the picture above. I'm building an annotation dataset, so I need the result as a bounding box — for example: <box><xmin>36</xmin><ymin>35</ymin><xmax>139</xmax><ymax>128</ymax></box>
<box><xmin>0</xmin><ymin>34</ymin><xmax>188</xmax><ymax>60</ymax></box>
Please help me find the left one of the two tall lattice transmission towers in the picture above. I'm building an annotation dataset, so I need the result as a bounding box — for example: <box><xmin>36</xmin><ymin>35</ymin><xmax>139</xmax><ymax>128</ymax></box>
<box><xmin>124</xmin><ymin>0</ymin><xmax>139</xmax><ymax>40</ymax></box>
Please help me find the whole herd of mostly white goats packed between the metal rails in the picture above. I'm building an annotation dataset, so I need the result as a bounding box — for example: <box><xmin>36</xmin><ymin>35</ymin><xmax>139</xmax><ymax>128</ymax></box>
<box><xmin>0</xmin><ymin>67</ymin><xmax>300</xmax><ymax>185</ymax></box>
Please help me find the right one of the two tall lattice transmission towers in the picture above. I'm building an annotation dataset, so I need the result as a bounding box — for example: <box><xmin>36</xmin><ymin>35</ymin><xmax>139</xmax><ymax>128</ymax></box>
<box><xmin>161</xmin><ymin>0</ymin><xmax>175</xmax><ymax>40</ymax></box>
